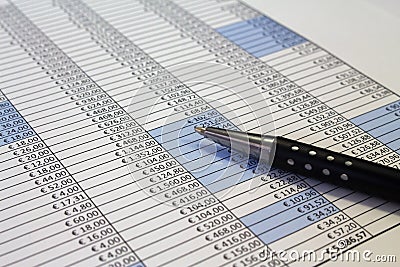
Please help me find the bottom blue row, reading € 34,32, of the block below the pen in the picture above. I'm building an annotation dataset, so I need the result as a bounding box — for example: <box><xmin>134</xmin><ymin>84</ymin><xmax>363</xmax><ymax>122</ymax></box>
<box><xmin>256</xmin><ymin>207</ymin><xmax>338</xmax><ymax>244</ymax></box>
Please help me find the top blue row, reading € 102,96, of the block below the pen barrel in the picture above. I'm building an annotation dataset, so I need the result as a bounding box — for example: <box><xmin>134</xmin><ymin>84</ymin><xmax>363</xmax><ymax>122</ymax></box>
<box><xmin>240</xmin><ymin>189</ymin><xmax>318</xmax><ymax>225</ymax></box>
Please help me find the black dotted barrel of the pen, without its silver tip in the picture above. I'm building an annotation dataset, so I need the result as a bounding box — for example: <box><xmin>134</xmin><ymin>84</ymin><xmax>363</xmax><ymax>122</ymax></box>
<box><xmin>273</xmin><ymin>137</ymin><xmax>400</xmax><ymax>201</ymax></box>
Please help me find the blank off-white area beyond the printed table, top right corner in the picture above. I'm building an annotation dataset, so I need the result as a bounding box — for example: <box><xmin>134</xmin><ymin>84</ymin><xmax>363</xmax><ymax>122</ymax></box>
<box><xmin>245</xmin><ymin>0</ymin><xmax>400</xmax><ymax>93</ymax></box>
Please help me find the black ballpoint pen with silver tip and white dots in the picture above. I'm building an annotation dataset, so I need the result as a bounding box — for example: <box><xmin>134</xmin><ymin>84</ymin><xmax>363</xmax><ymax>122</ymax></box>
<box><xmin>195</xmin><ymin>127</ymin><xmax>400</xmax><ymax>201</ymax></box>
